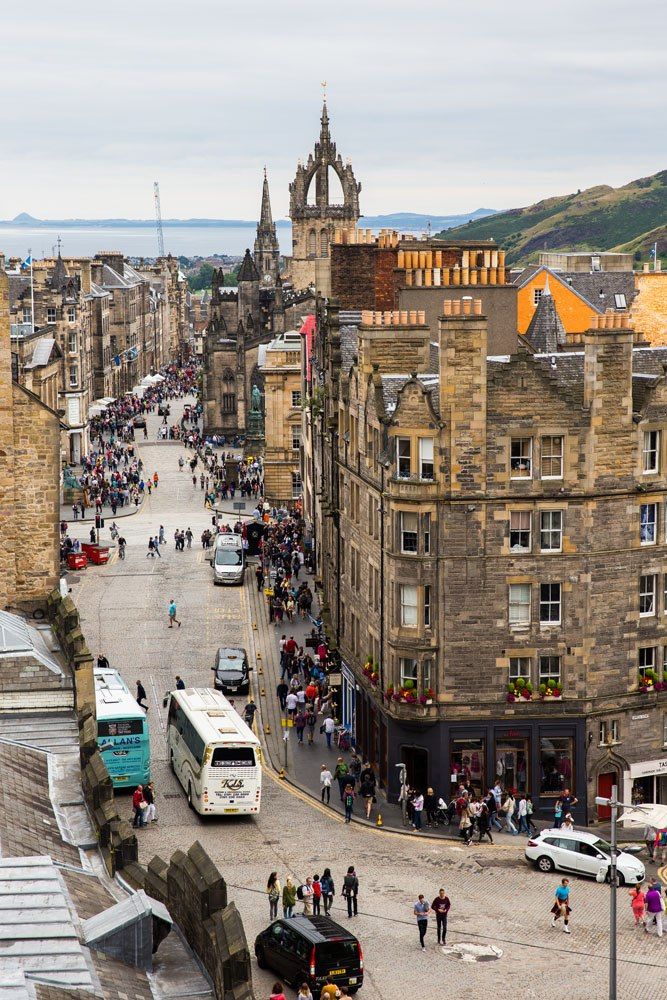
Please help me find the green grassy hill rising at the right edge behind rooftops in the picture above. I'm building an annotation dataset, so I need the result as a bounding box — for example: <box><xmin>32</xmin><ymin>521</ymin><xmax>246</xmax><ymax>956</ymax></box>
<box><xmin>440</xmin><ymin>170</ymin><xmax>667</xmax><ymax>264</ymax></box>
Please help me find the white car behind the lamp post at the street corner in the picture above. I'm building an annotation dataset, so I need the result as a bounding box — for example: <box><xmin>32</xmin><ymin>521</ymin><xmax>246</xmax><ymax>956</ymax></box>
<box><xmin>526</xmin><ymin>830</ymin><xmax>646</xmax><ymax>885</ymax></box>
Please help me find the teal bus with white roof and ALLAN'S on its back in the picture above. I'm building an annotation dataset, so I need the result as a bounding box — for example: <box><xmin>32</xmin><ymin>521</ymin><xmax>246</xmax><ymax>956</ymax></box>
<box><xmin>95</xmin><ymin>667</ymin><xmax>151</xmax><ymax>788</ymax></box>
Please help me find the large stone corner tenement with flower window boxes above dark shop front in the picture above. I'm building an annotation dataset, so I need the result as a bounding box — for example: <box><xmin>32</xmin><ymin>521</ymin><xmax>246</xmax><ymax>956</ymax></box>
<box><xmin>304</xmin><ymin>289</ymin><xmax>667</xmax><ymax>822</ymax></box>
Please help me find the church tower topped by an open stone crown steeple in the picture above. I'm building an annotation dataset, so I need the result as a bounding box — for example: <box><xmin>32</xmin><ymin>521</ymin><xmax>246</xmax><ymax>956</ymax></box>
<box><xmin>289</xmin><ymin>98</ymin><xmax>361</xmax><ymax>295</ymax></box>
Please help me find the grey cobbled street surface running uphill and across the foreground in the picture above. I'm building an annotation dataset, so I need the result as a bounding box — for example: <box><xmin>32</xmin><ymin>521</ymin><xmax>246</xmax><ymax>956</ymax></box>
<box><xmin>70</xmin><ymin>398</ymin><xmax>667</xmax><ymax>1000</ymax></box>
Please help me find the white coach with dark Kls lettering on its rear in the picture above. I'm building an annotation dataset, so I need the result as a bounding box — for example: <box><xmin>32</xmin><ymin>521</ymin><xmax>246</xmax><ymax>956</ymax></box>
<box><xmin>164</xmin><ymin>688</ymin><xmax>262</xmax><ymax>816</ymax></box>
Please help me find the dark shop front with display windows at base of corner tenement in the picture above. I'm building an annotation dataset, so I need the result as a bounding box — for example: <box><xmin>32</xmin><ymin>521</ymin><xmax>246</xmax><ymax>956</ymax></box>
<box><xmin>388</xmin><ymin>718</ymin><xmax>587</xmax><ymax>823</ymax></box>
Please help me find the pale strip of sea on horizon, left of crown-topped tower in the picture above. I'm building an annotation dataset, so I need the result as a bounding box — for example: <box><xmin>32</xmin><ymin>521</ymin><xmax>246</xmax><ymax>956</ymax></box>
<box><xmin>0</xmin><ymin>224</ymin><xmax>292</xmax><ymax>260</ymax></box>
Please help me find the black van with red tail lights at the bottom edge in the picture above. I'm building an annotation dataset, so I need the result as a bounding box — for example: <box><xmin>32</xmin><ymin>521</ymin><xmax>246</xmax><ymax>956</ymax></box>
<box><xmin>255</xmin><ymin>916</ymin><xmax>364</xmax><ymax>996</ymax></box>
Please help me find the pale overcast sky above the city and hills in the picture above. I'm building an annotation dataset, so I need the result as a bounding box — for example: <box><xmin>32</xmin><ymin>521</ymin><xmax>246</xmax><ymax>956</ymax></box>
<box><xmin>0</xmin><ymin>0</ymin><xmax>667</xmax><ymax>219</ymax></box>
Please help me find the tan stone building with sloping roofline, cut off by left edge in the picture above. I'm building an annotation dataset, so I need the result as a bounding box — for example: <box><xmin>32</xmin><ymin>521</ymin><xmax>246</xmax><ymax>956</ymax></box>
<box><xmin>0</xmin><ymin>255</ymin><xmax>60</xmax><ymax>610</ymax></box>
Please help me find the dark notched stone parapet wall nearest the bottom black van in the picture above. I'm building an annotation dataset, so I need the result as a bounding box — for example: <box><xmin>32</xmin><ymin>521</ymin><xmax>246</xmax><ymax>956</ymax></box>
<box><xmin>140</xmin><ymin>841</ymin><xmax>255</xmax><ymax>1000</ymax></box>
